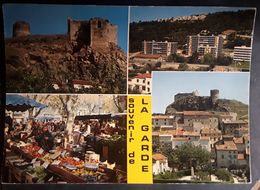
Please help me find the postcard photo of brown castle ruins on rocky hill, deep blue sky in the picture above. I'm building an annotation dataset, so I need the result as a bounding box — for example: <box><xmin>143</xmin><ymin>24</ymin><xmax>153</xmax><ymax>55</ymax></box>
<box><xmin>3</xmin><ymin>4</ymin><xmax>128</xmax><ymax>94</ymax></box>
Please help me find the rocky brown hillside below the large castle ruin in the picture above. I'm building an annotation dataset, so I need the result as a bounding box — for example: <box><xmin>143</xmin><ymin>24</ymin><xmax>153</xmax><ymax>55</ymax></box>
<box><xmin>5</xmin><ymin>35</ymin><xmax>126</xmax><ymax>93</ymax></box>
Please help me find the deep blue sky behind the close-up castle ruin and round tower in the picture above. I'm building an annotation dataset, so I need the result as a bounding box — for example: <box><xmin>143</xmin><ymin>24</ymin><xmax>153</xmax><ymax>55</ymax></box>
<box><xmin>3</xmin><ymin>4</ymin><xmax>128</xmax><ymax>52</ymax></box>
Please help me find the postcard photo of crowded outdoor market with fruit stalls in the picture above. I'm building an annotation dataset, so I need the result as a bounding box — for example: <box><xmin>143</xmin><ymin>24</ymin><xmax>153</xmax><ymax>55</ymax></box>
<box><xmin>3</xmin><ymin>94</ymin><xmax>127</xmax><ymax>184</ymax></box>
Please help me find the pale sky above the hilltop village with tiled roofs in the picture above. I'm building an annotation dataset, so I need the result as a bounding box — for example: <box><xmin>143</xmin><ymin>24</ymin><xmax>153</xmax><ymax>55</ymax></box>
<box><xmin>152</xmin><ymin>72</ymin><xmax>249</xmax><ymax>113</ymax></box>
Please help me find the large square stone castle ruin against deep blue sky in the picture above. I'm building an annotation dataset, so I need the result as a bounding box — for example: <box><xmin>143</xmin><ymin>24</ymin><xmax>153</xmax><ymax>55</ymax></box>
<box><xmin>68</xmin><ymin>18</ymin><xmax>117</xmax><ymax>51</ymax></box>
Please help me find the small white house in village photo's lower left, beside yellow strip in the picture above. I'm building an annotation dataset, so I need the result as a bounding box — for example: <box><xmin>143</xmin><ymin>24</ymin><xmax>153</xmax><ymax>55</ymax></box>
<box><xmin>152</xmin><ymin>153</ymin><xmax>172</xmax><ymax>175</ymax></box>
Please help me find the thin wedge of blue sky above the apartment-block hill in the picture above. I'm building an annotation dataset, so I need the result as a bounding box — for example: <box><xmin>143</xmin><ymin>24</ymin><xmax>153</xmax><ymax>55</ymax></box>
<box><xmin>130</xmin><ymin>6</ymin><xmax>254</xmax><ymax>22</ymax></box>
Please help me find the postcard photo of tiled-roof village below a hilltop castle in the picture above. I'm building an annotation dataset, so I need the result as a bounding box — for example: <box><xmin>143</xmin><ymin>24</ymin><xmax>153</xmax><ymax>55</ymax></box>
<box><xmin>152</xmin><ymin>72</ymin><xmax>251</xmax><ymax>184</ymax></box>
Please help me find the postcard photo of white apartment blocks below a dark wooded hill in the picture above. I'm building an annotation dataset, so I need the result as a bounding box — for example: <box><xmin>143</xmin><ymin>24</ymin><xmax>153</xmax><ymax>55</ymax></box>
<box><xmin>128</xmin><ymin>6</ymin><xmax>256</xmax><ymax>94</ymax></box>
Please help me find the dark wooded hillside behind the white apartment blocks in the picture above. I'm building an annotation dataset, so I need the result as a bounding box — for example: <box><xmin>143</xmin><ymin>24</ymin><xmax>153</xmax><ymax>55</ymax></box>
<box><xmin>129</xmin><ymin>10</ymin><xmax>255</xmax><ymax>52</ymax></box>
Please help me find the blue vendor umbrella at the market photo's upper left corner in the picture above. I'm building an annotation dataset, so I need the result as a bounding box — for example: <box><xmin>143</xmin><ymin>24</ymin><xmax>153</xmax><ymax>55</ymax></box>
<box><xmin>5</xmin><ymin>95</ymin><xmax>47</xmax><ymax>111</ymax></box>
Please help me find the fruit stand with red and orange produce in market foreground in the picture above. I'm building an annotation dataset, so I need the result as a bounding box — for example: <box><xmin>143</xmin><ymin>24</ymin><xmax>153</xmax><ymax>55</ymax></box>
<box><xmin>6</xmin><ymin>144</ymin><xmax>125</xmax><ymax>183</ymax></box>
